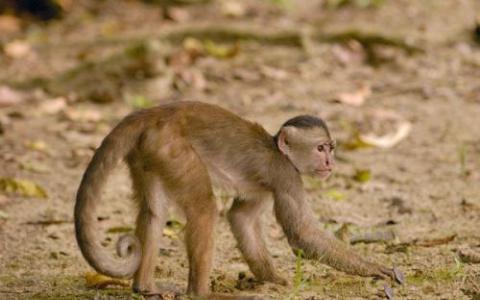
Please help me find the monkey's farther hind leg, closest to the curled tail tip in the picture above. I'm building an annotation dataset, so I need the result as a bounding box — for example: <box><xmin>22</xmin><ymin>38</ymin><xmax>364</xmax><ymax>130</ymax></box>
<box><xmin>131</xmin><ymin>168</ymin><xmax>168</xmax><ymax>295</ymax></box>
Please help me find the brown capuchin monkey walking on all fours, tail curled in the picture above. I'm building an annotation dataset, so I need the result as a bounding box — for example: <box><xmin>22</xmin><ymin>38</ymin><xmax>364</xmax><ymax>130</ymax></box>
<box><xmin>75</xmin><ymin>102</ymin><xmax>395</xmax><ymax>299</ymax></box>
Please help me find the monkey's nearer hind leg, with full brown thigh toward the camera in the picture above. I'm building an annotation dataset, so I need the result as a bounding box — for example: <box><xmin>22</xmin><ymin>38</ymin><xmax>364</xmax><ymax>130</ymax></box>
<box><xmin>158</xmin><ymin>142</ymin><xmax>218</xmax><ymax>297</ymax></box>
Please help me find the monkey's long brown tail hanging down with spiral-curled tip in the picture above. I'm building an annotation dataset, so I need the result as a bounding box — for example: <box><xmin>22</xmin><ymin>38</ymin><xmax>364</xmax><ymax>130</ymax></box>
<box><xmin>74</xmin><ymin>120</ymin><xmax>141</xmax><ymax>278</ymax></box>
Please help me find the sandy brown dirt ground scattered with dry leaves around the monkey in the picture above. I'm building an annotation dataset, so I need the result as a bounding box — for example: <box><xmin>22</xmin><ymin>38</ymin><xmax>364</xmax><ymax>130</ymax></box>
<box><xmin>0</xmin><ymin>0</ymin><xmax>480</xmax><ymax>300</ymax></box>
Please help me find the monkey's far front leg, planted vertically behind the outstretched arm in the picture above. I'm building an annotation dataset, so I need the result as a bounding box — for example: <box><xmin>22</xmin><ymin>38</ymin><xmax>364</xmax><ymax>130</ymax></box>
<box><xmin>228</xmin><ymin>198</ymin><xmax>288</xmax><ymax>285</ymax></box>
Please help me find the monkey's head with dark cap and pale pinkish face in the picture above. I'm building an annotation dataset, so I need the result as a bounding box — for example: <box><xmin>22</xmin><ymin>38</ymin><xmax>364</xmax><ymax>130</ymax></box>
<box><xmin>274</xmin><ymin>115</ymin><xmax>335</xmax><ymax>179</ymax></box>
